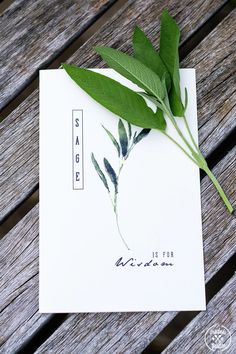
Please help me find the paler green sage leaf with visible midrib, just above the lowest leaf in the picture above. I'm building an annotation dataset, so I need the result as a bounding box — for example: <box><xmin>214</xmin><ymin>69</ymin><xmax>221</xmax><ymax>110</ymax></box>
<box><xmin>95</xmin><ymin>47</ymin><xmax>164</xmax><ymax>99</ymax></box>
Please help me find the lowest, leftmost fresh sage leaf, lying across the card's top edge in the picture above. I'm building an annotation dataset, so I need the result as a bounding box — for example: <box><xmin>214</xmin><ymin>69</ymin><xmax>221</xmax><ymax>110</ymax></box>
<box><xmin>62</xmin><ymin>64</ymin><xmax>164</xmax><ymax>129</ymax></box>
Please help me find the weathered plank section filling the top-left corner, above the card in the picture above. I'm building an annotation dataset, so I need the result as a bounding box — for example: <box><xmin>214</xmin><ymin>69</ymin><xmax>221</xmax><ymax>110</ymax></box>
<box><xmin>0</xmin><ymin>0</ymin><xmax>115</xmax><ymax>109</ymax></box>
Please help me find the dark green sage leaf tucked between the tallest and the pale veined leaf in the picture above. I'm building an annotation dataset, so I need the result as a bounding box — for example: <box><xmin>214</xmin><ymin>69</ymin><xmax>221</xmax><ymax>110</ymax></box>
<box><xmin>133</xmin><ymin>26</ymin><xmax>171</xmax><ymax>90</ymax></box>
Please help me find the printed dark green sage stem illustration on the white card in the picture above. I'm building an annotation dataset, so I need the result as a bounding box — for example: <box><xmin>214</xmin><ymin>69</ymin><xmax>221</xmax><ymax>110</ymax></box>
<box><xmin>91</xmin><ymin>119</ymin><xmax>150</xmax><ymax>250</ymax></box>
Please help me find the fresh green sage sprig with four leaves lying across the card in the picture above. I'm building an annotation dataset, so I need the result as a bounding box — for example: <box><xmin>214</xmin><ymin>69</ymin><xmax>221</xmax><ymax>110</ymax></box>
<box><xmin>62</xmin><ymin>10</ymin><xmax>234</xmax><ymax>213</ymax></box>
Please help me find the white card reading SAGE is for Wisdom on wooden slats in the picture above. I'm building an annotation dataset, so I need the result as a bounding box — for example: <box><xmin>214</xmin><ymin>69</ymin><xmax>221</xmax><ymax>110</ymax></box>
<box><xmin>39</xmin><ymin>69</ymin><xmax>205</xmax><ymax>313</ymax></box>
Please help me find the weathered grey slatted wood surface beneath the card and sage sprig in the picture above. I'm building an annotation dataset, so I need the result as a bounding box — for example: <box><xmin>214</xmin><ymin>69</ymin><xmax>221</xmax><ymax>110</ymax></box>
<box><xmin>0</xmin><ymin>0</ymin><xmax>236</xmax><ymax>354</ymax></box>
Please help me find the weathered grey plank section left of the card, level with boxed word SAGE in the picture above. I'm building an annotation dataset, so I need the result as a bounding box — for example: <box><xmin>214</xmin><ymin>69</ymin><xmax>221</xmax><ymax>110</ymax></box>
<box><xmin>0</xmin><ymin>94</ymin><xmax>39</xmax><ymax>221</ymax></box>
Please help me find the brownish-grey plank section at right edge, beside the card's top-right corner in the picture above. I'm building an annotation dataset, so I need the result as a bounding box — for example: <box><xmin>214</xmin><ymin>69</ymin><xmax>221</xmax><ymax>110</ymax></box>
<box><xmin>183</xmin><ymin>10</ymin><xmax>236</xmax><ymax>156</ymax></box>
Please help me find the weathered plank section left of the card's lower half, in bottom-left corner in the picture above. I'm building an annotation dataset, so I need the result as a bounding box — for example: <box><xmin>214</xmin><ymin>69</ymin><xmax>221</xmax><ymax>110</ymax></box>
<box><xmin>0</xmin><ymin>206</ymin><xmax>49</xmax><ymax>353</ymax></box>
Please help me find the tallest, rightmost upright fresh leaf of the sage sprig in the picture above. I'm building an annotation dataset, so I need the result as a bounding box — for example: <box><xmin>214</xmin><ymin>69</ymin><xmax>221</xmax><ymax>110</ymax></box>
<box><xmin>160</xmin><ymin>10</ymin><xmax>184</xmax><ymax>117</ymax></box>
